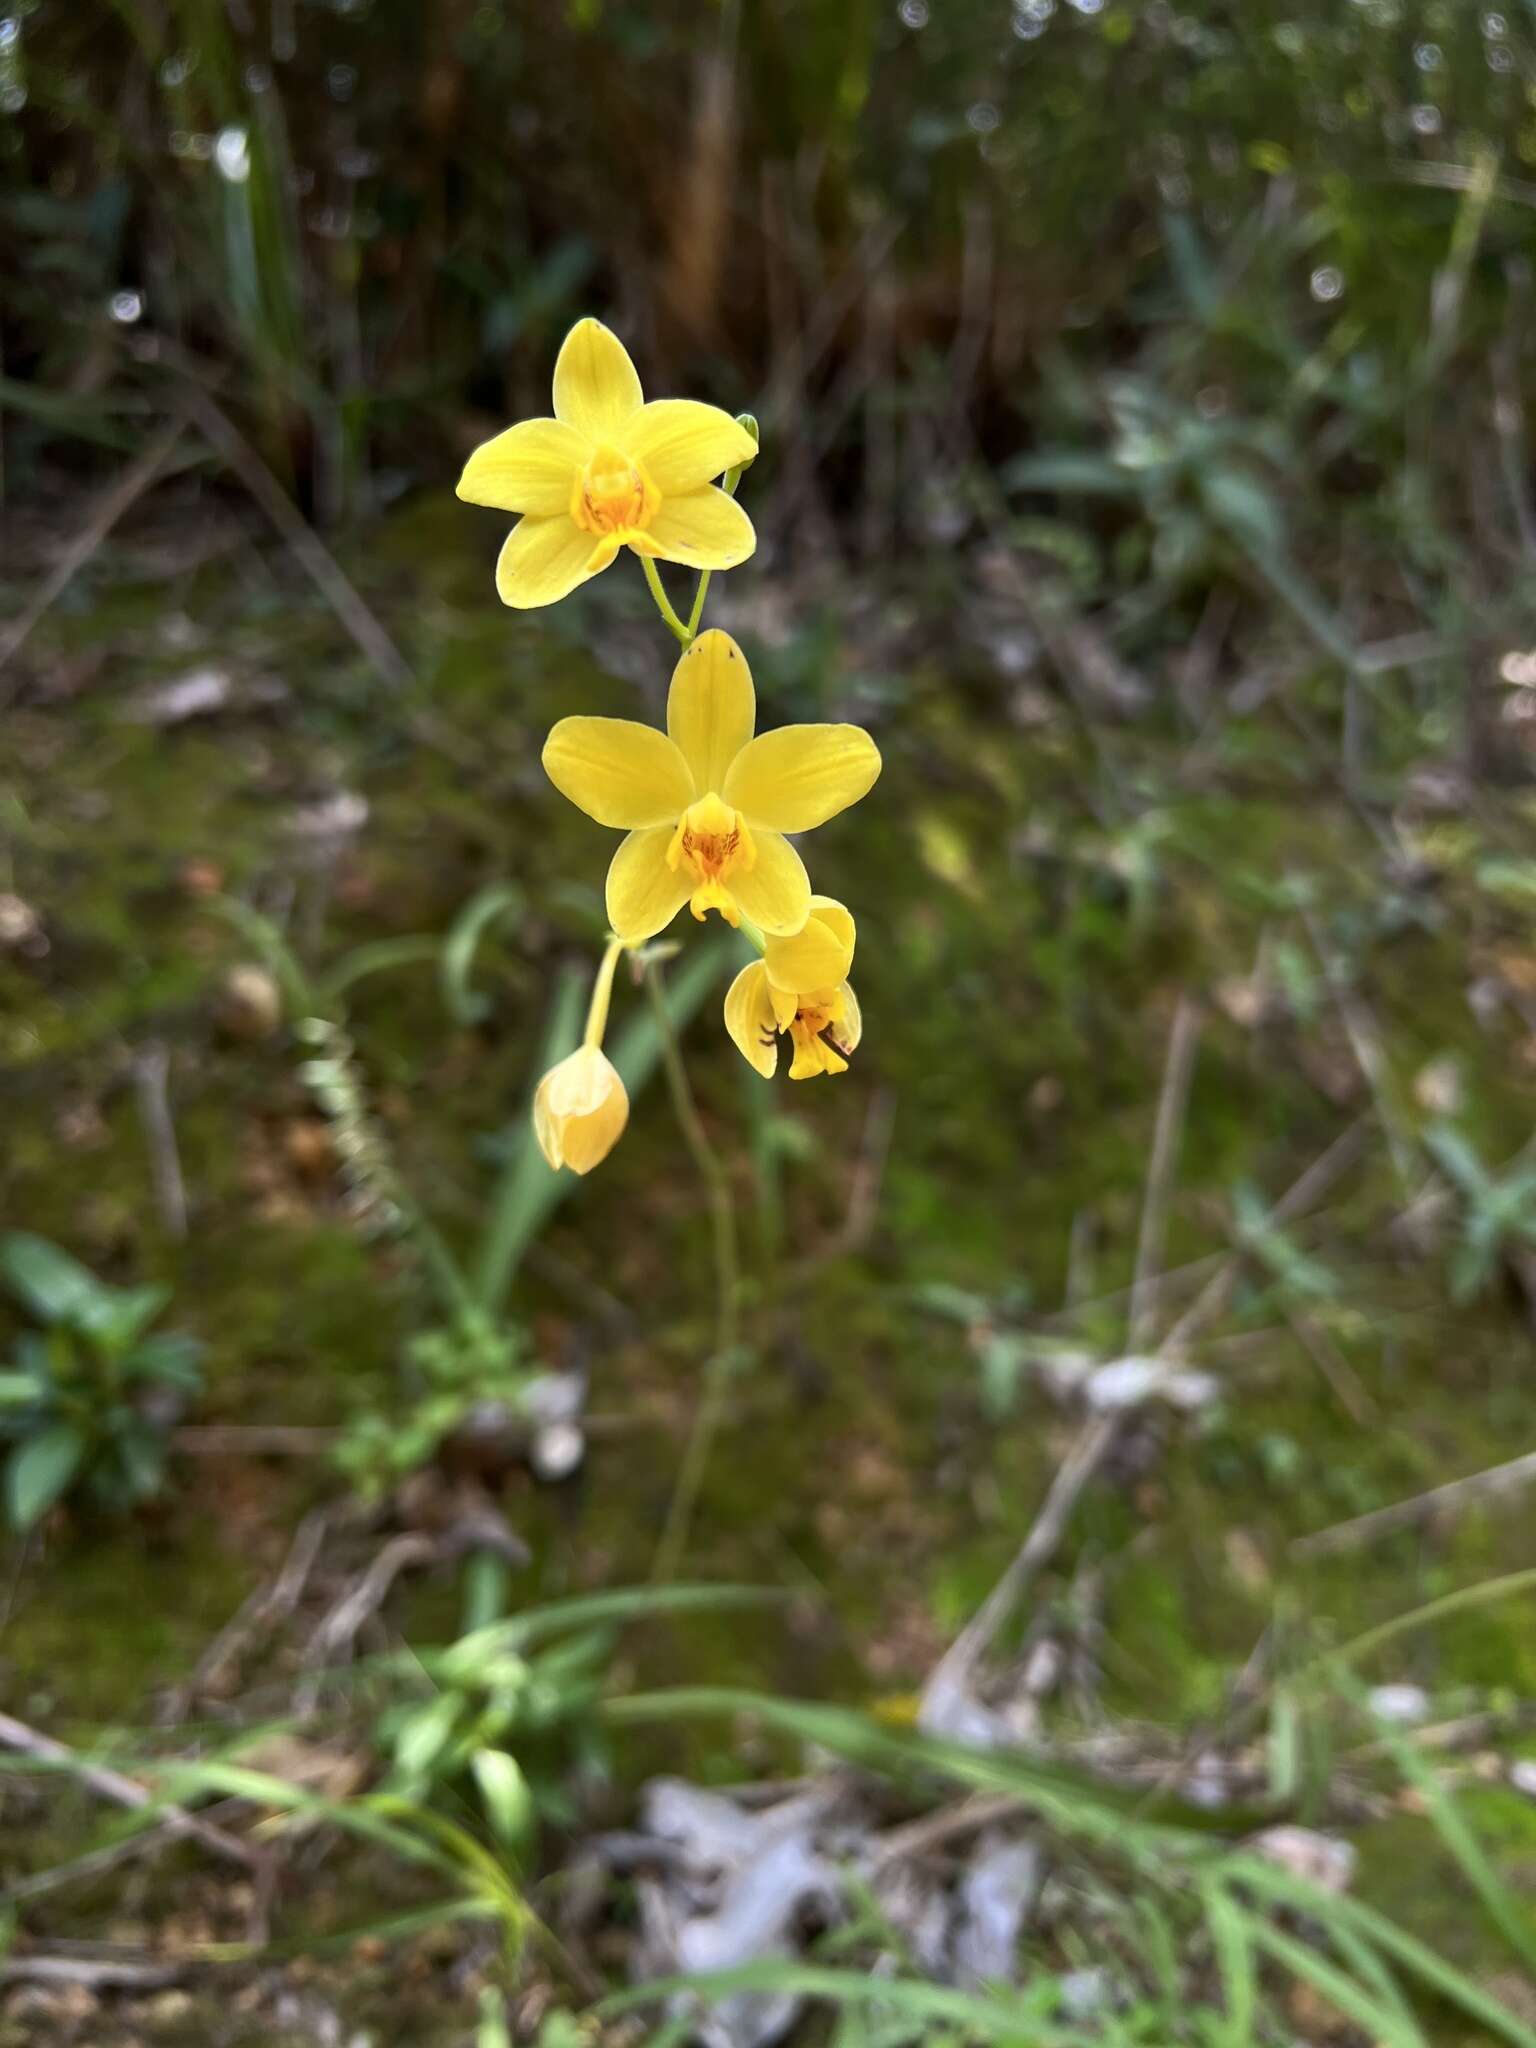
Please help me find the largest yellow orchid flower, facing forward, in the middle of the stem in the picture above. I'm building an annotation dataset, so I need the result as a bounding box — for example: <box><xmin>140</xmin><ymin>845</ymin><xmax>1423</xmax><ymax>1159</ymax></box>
<box><xmin>545</xmin><ymin>629</ymin><xmax>881</xmax><ymax>946</ymax></box>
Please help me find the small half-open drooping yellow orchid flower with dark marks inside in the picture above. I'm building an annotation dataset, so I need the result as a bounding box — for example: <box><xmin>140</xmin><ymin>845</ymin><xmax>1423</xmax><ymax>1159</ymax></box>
<box><xmin>725</xmin><ymin>897</ymin><xmax>864</xmax><ymax>1081</ymax></box>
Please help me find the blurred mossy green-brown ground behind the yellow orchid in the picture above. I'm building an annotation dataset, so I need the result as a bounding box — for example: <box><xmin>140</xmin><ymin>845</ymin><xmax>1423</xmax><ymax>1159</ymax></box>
<box><xmin>0</xmin><ymin>502</ymin><xmax>1536</xmax><ymax>2040</ymax></box>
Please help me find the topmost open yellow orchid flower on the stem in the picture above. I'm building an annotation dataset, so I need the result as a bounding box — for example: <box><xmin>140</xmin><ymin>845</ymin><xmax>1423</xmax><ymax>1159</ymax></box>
<box><xmin>459</xmin><ymin>319</ymin><xmax>758</xmax><ymax>610</ymax></box>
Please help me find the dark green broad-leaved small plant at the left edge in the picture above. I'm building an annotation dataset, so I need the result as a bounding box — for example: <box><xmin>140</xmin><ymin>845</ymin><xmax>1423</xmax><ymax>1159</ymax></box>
<box><xmin>0</xmin><ymin>1231</ymin><xmax>203</xmax><ymax>1530</ymax></box>
